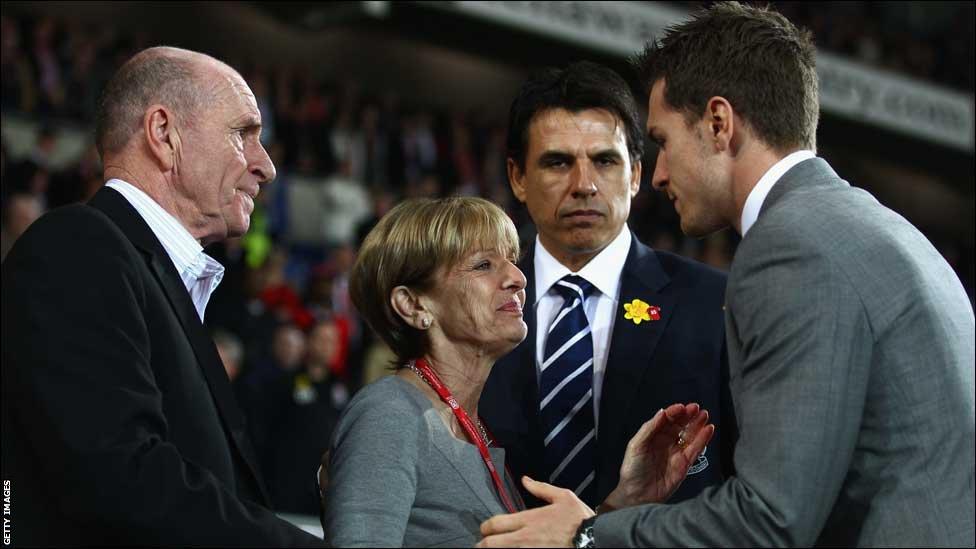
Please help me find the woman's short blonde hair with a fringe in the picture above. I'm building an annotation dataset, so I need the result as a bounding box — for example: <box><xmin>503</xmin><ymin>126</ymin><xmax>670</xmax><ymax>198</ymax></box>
<box><xmin>349</xmin><ymin>197</ymin><xmax>519</xmax><ymax>365</ymax></box>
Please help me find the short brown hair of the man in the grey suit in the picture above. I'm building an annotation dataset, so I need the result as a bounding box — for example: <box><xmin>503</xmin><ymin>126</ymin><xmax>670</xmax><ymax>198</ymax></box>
<box><xmin>633</xmin><ymin>2</ymin><xmax>820</xmax><ymax>152</ymax></box>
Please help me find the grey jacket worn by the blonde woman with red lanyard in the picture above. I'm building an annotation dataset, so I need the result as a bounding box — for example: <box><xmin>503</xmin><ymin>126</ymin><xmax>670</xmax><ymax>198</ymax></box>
<box><xmin>324</xmin><ymin>376</ymin><xmax>518</xmax><ymax>547</ymax></box>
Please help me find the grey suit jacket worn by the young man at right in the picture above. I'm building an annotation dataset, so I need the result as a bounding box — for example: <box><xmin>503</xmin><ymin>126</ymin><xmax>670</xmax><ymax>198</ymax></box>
<box><xmin>594</xmin><ymin>158</ymin><xmax>976</xmax><ymax>547</ymax></box>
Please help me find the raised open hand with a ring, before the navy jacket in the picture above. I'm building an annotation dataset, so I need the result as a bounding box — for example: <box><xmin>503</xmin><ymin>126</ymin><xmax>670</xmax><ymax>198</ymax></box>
<box><xmin>598</xmin><ymin>403</ymin><xmax>715</xmax><ymax>512</ymax></box>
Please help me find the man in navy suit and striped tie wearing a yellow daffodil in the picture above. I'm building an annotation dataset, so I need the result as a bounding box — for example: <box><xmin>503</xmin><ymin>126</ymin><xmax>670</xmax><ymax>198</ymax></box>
<box><xmin>479</xmin><ymin>62</ymin><xmax>735</xmax><ymax>510</ymax></box>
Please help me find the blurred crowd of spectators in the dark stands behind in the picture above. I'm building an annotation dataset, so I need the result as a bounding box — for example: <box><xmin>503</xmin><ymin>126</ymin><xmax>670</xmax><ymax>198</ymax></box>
<box><xmin>2</xmin><ymin>2</ymin><xmax>973</xmax><ymax>514</ymax></box>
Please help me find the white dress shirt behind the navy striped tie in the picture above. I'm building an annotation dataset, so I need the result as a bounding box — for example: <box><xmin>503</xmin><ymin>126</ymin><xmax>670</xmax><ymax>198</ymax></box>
<box><xmin>533</xmin><ymin>224</ymin><xmax>632</xmax><ymax>429</ymax></box>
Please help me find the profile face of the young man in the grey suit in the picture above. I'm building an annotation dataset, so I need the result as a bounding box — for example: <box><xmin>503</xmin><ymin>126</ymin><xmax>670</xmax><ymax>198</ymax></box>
<box><xmin>647</xmin><ymin>80</ymin><xmax>732</xmax><ymax>237</ymax></box>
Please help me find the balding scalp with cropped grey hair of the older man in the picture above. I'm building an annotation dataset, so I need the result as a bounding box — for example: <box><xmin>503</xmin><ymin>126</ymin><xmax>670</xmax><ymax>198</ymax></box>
<box><xmin>95</xmin><ymin>47</ymin><xmax>236</xmax><ymax>159</ymax></box>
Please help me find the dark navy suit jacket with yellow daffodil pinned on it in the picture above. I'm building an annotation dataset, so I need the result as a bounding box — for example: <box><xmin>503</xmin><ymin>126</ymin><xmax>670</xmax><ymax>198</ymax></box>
<box><xmin>478</xmin><ymin>233</ymin><xmax>735</xmax><ymax>506</ymax></box>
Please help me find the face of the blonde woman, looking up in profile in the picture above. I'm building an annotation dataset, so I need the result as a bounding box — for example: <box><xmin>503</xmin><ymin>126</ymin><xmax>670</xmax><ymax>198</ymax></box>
<box><xmin>425</xmin><ymin>250</ymin><xmax>528</xmax><ymax>359</ymax></box>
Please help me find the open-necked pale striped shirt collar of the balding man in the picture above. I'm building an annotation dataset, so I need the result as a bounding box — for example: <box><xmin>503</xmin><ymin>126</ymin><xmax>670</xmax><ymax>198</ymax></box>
<box><xmin>105</xmin><ymin>179</ymin><xmax>224</xmax><ymax>322</ymax></box>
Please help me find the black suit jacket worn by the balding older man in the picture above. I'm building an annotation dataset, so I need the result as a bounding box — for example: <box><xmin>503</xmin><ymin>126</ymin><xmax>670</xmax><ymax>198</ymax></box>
<box><xmin>2</xmin><ymin>188</ymin><xmax>321</xmax><ymax>546</ymax></box>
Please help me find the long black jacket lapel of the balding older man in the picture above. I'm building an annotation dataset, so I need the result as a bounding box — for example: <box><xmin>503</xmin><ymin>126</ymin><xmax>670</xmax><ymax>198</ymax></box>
<box><xmin>90</xmin><ymin>187</ymin><xmax>268</xmax><ymax>501</ymax></box>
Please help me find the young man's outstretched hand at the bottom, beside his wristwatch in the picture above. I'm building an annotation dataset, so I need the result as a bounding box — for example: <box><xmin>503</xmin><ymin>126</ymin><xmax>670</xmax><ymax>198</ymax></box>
<box><xmin>475</xmin><ymin>477</ymin><xmax>594</xmax><ymax>547</ymax></box>
